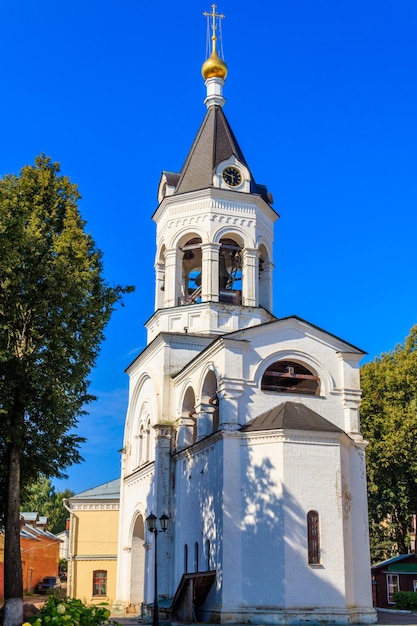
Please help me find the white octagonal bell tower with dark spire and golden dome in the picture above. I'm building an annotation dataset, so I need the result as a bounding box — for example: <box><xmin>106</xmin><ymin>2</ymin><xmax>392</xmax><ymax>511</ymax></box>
<box><xmin>146</xmin><ymin>4</ymin><xmax>278</xmax><ymax>342</ymax></box>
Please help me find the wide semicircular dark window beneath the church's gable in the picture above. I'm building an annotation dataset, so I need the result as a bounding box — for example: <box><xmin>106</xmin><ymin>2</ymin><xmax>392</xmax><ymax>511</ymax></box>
<box><xmin>261</xmin><ymin>361</ymin><xmax>319</xmax><ymax>396</ymax></box>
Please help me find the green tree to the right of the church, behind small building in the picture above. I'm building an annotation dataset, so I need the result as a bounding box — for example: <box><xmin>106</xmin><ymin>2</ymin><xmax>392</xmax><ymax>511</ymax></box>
<box><xmin>361</xmin><ymin>326</ymin><xmax>417</xmax><ymax>562</ymax></box>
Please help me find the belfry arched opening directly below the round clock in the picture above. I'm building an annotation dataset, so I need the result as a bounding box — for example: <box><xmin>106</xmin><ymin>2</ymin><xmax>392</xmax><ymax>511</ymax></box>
<box><xmin>219</xmin><ymin>237</ymin><xmax>242</xmax><ymax>304</ymax></box>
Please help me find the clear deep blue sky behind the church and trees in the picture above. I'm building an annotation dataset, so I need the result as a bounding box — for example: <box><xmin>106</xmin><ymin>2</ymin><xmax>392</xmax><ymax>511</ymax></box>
<box><xmin>0</xmin><ymin>0</ymin><xmax>417</xmax><ymax>492</ymax></box>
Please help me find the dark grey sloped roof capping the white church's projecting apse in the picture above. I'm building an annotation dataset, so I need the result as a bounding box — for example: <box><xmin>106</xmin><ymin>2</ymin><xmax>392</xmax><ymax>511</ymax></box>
<box><xmin>241</xmin><ymin>402</ymin><xmax>343</xmax><ymax>433</ymax></box>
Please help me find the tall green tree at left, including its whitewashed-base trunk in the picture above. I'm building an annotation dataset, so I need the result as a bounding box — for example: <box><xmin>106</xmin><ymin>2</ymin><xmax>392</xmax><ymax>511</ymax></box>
<box><xmin>0</xmin><ymin>155</ymin><xmax>132</xmax><ymax>626</ymax></box>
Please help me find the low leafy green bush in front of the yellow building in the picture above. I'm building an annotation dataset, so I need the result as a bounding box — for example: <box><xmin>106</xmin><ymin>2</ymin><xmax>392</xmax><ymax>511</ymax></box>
<box><xmin>30</xmin><ymin>596</ymin><xmax>118</xmax><ymax>626</ymax></box>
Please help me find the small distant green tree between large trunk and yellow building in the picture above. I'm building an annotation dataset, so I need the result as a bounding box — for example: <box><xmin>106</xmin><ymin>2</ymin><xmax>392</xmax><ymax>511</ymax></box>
<box><xmin>20</xmin><ymin>476</ymin><xmax>74</xmax><ymax>533</ymax></box>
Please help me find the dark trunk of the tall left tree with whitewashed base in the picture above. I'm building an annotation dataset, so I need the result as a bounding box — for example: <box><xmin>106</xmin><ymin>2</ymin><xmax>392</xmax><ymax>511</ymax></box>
<box><xmin>4</xmin><ymin>444</ymin><xmax>23</xmax><ymax>626</ymax></box>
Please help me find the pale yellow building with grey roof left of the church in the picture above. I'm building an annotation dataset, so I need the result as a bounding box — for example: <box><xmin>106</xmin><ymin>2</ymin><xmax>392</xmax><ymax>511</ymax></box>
<box><xmin>66</xmin><ymin>479</ymin><xmax>120</xmax><ymax>606</ymax></box>
